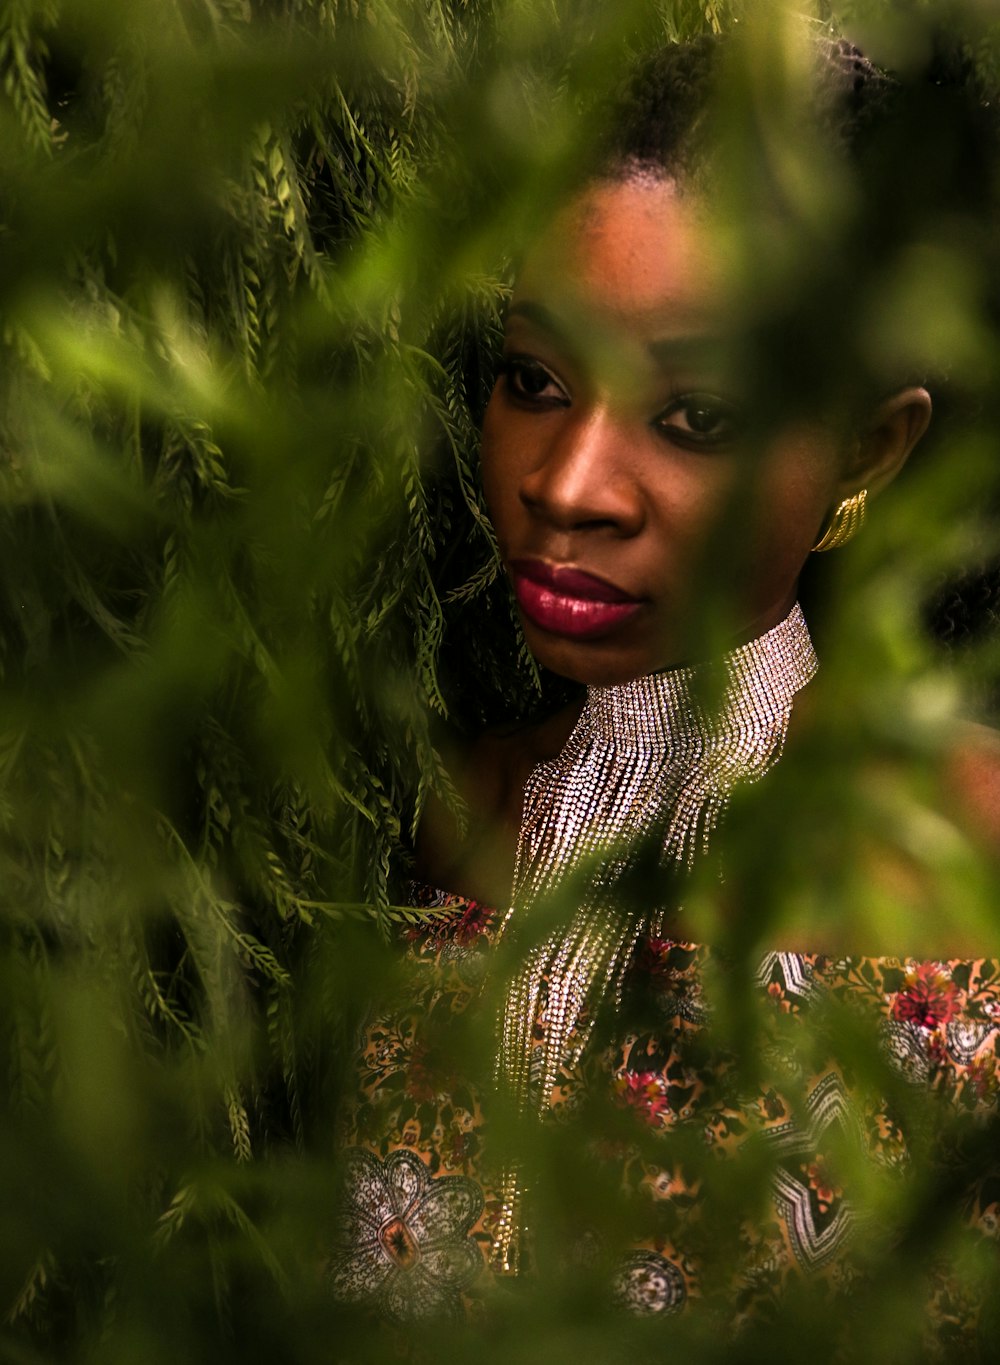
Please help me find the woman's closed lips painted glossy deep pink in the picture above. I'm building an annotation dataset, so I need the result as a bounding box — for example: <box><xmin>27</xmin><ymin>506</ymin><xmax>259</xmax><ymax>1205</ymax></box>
<box><xmin>510</xmin><ymin>560</ymin><xmax>643</xmax><ymax>640</ymax></box>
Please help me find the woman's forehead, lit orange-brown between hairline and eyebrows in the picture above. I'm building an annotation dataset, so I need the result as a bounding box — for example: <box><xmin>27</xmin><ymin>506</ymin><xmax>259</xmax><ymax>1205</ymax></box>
<box><xmin>512</xmin><ymin>175</ymin><xmax>730</xmax><ymax>340</ymax></box>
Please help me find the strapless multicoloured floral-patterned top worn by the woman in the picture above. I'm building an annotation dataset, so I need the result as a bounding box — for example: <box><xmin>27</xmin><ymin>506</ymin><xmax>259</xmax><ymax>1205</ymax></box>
<box><xmin>329</xmin><ymin>893</ymin><xmax>1000</xmax><ymax>1350</ymax></box>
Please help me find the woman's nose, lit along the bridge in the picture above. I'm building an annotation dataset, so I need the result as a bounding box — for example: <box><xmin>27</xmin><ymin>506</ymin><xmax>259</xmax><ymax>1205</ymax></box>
<box><xmin>520</xmin><ymin>411</ymin><xmax>645</xmax><ymax>536</ymax></box>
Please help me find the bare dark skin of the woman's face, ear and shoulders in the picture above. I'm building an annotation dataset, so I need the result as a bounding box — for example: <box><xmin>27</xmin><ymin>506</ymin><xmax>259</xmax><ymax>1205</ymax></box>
<box><xmin>419</xmin><ymin>173</ymin><xmax>1000</xmax><ymax>956</ymax></box>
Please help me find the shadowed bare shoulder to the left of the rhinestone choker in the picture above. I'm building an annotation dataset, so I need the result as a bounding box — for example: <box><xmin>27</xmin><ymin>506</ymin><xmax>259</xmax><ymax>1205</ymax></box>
<box><xmin>416</xmin><ymin>702</ymin><xmax>580</xmax><ymax>905</ymax></box>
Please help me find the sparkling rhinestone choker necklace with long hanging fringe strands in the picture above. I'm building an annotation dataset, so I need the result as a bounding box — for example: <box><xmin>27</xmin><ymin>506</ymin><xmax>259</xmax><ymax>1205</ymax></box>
<box><xmin>492</xmin><ymin>603</ymin><xmax>816</xmax><ymax>1272</ymax></box>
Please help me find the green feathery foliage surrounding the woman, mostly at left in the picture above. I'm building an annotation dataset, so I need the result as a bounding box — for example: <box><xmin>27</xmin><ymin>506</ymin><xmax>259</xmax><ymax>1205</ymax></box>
<box><xmin>0</xmin><ymin>0</ymin><xmax>997</xmax><ymax>1362</ymax></box>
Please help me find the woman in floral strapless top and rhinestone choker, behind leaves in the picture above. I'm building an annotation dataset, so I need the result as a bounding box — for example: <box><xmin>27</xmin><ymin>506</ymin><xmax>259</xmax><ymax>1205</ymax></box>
<box><xmin>330</xmin><ymin>32</ymin><xmax>1000</xmax><ymax>1345</ymax></box>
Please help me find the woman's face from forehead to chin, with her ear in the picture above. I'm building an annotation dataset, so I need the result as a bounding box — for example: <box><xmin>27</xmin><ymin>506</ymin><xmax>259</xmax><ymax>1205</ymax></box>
<box><xmin>483</xmin><ymin>176</ymin><xmax>843</xmax><ymax>684</ymax></box>
